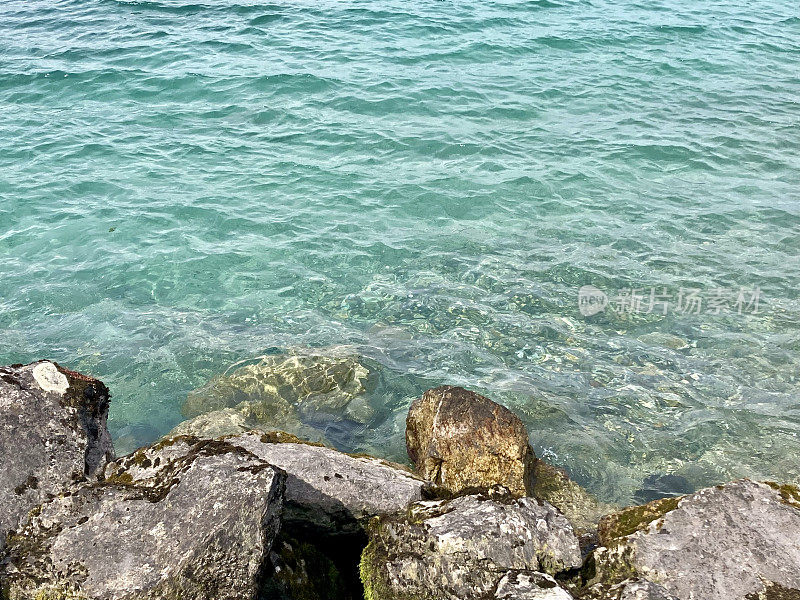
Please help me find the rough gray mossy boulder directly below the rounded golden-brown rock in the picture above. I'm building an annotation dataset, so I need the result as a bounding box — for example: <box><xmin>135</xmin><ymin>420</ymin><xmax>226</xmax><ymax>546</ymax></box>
<box><xmin>361</xmin><ymin>495</ymin><xmax>581</xmax><ymax>600</ymax></box>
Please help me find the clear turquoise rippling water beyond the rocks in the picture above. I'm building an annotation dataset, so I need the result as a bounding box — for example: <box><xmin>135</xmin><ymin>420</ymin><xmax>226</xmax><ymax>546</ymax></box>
<box><xmin>0</xmin><ymin>0</ymin><xmax>800</xmax><ymax>502</ymax></box>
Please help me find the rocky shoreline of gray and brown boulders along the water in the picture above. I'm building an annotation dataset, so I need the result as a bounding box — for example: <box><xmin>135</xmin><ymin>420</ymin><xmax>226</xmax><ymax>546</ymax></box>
<box><xmin>0</xmin><ymin>361</ymin><xmax>800</xmax><ymax>600</ymax></box>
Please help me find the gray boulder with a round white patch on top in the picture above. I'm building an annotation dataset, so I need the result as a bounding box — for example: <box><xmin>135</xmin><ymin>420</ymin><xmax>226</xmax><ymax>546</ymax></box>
<box><xmin>0</xmin><ymin>361</ymin><xmax>114</xmax><ymax>549</ymax></box>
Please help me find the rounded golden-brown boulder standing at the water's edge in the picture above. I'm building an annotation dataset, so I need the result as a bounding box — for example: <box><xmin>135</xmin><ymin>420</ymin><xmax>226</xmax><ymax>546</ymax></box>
<box><xmin>406</xmin><ymin>386</ymin><xmax>536</xmax><ymax>496</ymax></box>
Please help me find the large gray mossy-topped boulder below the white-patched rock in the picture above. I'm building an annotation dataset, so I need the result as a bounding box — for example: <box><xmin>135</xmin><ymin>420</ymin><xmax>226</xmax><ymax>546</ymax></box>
<box><xmin>4</xmin><ymin>437</ymin><xmax>285</xmax><ymax>600</ymax></box>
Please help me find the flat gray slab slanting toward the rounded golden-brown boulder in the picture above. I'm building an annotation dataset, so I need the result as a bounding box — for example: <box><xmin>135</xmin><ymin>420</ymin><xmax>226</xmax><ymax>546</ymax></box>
<box><xmin>226</xmin><ymin>432</ymin><xmax>427</xmax><ymax>534</ymax></box>
